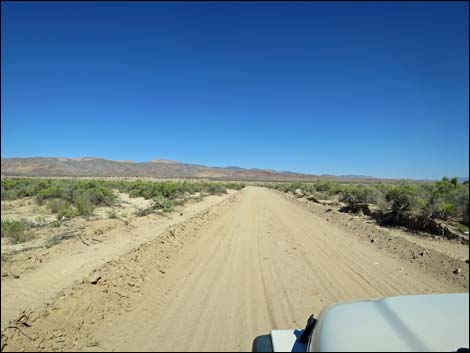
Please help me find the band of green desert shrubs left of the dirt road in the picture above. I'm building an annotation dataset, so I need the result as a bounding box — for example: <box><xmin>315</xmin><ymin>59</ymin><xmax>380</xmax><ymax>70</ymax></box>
<box><xmin>2</xmin><ymin>178</ymin><xmax>244</xmax><ymax>221</ymax></box>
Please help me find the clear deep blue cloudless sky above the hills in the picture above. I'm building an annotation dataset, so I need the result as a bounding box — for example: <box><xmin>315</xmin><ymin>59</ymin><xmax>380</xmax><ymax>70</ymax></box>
<box><xmin>1</xmin><ymin>1</ymin><xmax>469</xmax><ymax>178</ymax></box>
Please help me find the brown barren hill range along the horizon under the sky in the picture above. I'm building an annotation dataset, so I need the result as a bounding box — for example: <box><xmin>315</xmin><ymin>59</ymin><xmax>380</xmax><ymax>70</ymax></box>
<box><xmin>1</xmin><ymin>157</ymin><xmax>412</xmax><ymax>182</ymax></box>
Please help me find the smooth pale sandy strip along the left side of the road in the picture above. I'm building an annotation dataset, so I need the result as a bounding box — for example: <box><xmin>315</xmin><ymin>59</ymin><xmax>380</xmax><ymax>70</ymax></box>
<box><xmin>1</xmin><ymin>191</ymin><xmax>233</xmax><ymax>329</ymax></box>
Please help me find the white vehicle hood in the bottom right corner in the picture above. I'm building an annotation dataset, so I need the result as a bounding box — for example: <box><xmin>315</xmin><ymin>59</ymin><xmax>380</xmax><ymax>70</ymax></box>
<box><xmin>309</xmin><ymin>293</ymin><xmax>469</xmax><ymax>352</ymax></box>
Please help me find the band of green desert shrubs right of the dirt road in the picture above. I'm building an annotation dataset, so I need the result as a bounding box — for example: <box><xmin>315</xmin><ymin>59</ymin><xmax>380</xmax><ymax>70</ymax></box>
<box><xmin>270</xmin><ymin>177</ymin><xmax>469</xmax><ymax>232</ymax></box>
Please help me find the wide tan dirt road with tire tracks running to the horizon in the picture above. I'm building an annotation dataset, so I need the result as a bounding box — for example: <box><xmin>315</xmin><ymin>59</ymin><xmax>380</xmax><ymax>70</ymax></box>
<box><xmin>1</xmin><ymin>187</ymin><xmax>468</xmax><ymax>351</ymax></box>
